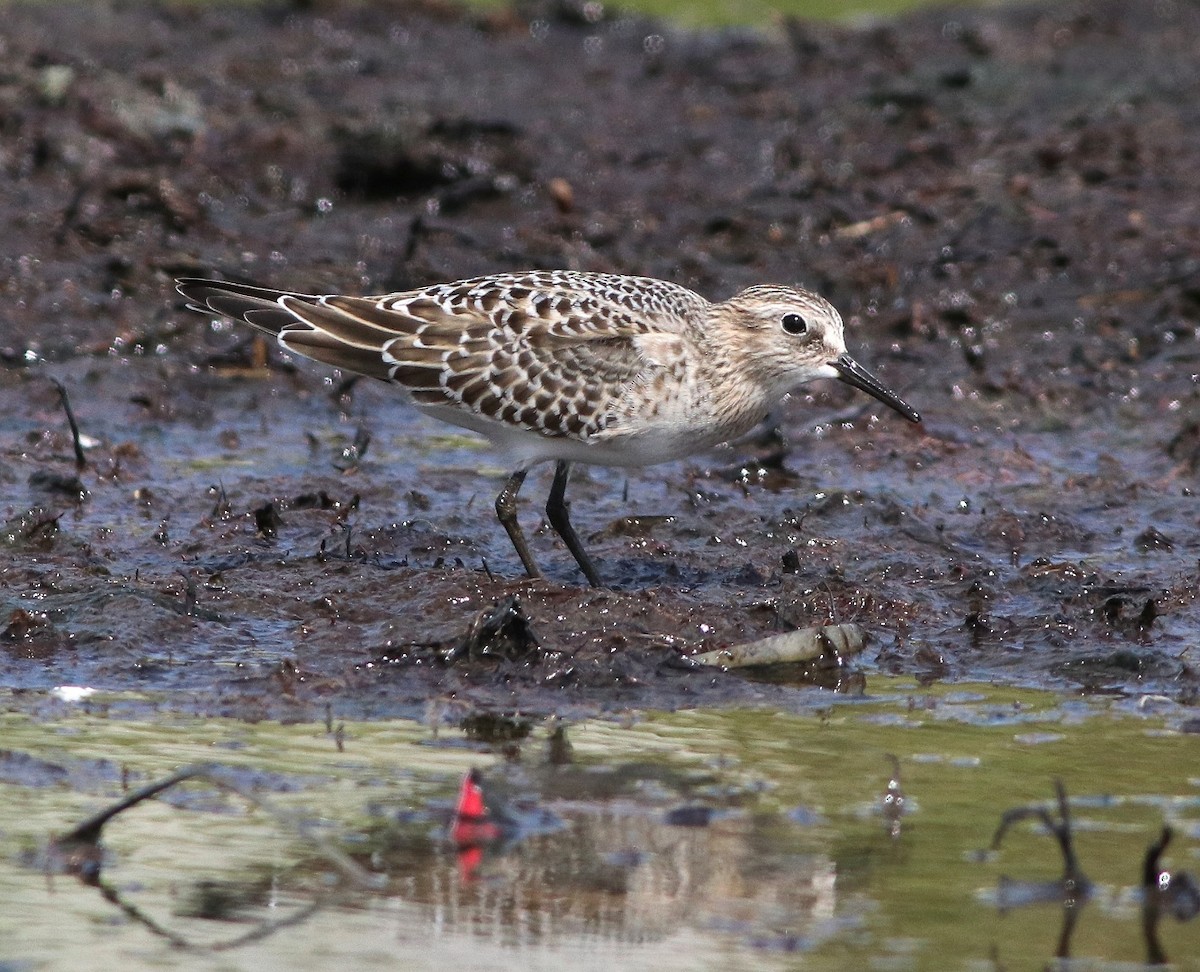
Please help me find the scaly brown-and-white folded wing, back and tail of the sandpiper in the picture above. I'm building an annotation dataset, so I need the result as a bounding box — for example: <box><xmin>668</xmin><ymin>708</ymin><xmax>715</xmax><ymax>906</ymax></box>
<box><xmin>179</xmin><ymin>271</ymin><xmax>707</xmax><ymax>439</ymax></box>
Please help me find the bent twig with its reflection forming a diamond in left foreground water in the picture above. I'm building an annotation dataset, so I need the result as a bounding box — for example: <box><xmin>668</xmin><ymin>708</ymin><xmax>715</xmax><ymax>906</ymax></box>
<box><xmin>49</xmin><ymin>764</ymin><xmax>383</xmax><ymax>952</ymax></box>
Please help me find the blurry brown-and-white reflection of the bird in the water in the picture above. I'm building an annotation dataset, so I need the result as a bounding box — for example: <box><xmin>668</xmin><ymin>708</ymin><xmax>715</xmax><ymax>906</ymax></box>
<box><xmin>360</xmin><ymin>766</ymin><xmax>836</xmax><ymax>949</ymax></box>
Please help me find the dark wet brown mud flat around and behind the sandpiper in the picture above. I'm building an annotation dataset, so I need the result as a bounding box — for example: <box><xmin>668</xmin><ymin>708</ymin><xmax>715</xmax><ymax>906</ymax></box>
<box><xmin>0</xmin><ymin>2</ymin><xmax>1200</xmax><ymax>718</ymax></box>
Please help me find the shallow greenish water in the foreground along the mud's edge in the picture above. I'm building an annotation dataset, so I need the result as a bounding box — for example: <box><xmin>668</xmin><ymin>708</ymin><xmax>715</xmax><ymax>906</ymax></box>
<box><xmin>0</xmin><ymin>680</ymin><xmax>1200</xmax><ymax>971</ymax></box>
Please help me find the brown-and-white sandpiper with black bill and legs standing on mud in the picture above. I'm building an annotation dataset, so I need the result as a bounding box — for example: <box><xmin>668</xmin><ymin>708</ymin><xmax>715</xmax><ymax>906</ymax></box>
<box><xmin>176</xmin><ymin>270</ymin><xmax>920</xmax><ymax>587</ymax></box>
